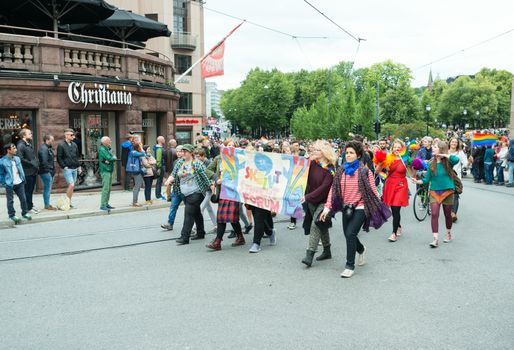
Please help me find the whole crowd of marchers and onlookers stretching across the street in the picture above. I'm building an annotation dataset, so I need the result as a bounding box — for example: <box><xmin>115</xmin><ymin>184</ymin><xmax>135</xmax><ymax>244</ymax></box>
<box><xmin>0</xmin><ymin>129</ymin><xmax>514</xmax><ymax>278</ymax></box>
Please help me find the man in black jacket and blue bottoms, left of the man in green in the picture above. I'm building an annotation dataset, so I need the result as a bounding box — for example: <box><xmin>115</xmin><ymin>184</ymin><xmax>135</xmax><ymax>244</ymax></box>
<box><xmin>57</xmin><ymin>129</ymin><xmax>80</xmax><ymax>208</ymax></box>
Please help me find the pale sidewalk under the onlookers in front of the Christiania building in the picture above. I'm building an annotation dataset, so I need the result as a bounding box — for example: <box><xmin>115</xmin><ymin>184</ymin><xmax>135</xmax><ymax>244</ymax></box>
<box><xmin>0</xmin><ymin>190</ymin><xmax>170</xmax><ymax>229</ymax></box>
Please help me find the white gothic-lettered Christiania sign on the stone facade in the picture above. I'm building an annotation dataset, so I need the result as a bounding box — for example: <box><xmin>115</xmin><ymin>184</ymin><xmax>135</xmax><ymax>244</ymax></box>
<box><xmin>68</xmin><ymin>81</ymin><xmax>132</xmax><ymax>108</ymax></box>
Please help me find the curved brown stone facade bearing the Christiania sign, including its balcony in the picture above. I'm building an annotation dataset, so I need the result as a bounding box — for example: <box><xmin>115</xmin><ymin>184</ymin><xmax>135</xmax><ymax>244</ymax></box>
<box><xmin>0</xmin><ymin>33</ymin><xmax>179</xmax><ymax>188</ymax></box>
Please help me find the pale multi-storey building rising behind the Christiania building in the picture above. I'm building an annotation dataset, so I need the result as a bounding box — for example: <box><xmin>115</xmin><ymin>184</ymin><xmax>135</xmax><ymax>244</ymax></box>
<box><xmin>109</xmin><ymin>0</ymin><xmax>207</xmax><ymax>144</ymax></box>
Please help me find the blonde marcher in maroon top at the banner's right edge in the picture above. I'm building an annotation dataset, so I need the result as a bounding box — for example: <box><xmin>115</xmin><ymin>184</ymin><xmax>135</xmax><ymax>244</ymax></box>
<box><xmin>301</xmin><ymin>140</ymin><xmax>337</xmax><ymax>267</ymax></box>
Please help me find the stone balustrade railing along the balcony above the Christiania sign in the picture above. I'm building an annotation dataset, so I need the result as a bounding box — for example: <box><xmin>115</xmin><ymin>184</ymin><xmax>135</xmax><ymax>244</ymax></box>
<box><xmin>0</xmin><ymin>27</ymin><xmax>174</xmax><ymax>84</ymax></box>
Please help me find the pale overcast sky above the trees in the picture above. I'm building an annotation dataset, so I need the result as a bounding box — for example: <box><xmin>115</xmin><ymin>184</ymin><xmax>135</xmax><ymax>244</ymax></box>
<box><xmin>199</xmin><ymin>0</ymin><xmax>514</xmax><ymax>89</ymax></box>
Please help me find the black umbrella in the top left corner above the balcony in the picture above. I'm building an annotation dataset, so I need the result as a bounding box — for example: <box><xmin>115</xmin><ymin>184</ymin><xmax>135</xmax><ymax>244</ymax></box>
<box><xmin>0</xmin><ymin>0</ymin><xmax>116</xmax><ymax>37</ymax></box>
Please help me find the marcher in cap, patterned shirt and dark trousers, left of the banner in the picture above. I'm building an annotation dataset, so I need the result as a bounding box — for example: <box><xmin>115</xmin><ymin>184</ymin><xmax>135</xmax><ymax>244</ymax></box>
<box><xmin>166</xmin><ymin>144</ymin><xmax>211</xmax><ymax>245</ymax></box>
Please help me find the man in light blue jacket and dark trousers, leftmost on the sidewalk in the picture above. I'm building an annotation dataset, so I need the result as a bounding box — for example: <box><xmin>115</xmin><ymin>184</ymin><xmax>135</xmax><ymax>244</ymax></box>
<box><xmin>0</xmin><ymin>143</ymin><xmax>32</xmax><ymax>224</ymax></box>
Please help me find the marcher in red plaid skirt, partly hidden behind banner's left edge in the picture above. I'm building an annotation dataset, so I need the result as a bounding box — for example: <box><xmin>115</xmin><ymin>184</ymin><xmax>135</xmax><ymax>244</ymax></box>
<box><xmin>207</xmin><ymin>139</ymin><xmax>246</xmax><ymax>250</ymax></box>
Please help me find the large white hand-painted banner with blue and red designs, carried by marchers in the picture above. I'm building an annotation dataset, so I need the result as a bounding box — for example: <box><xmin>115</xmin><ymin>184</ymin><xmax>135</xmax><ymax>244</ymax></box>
<box><xmin>220</xmin><ymin>147</ymin><xmax>310</xmax><ymax>218</ymax></box>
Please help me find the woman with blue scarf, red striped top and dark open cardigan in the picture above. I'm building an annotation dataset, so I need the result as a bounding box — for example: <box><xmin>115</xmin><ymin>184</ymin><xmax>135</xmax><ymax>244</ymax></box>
<box><xmin>320</xmin><ymin>141</ymin><xmax>391</xmax><ymax>278</ymax></box>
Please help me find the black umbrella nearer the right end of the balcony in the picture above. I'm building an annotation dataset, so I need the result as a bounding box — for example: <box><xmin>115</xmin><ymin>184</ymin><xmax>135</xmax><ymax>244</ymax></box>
<box><xmin>65</xmin><ymin>10</ymin><xmax>171</xmax><ymax>47</ymax></box>
